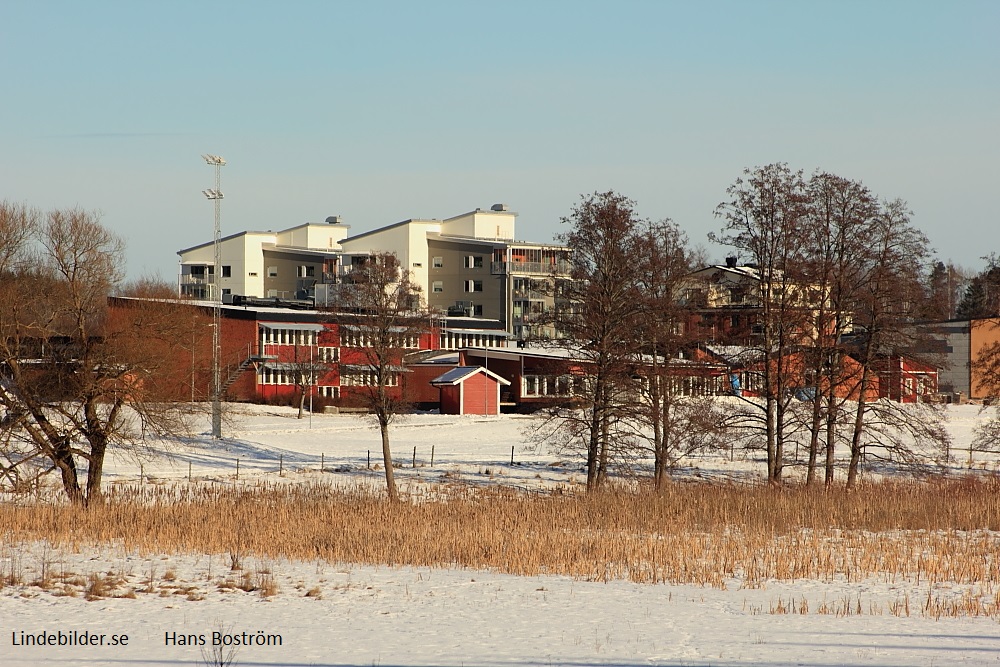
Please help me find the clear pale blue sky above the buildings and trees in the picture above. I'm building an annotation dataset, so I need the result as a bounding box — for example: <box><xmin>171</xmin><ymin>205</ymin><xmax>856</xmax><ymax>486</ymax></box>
<box><xmin>0</xmin><ymin>0</ymin><xmax>1000</xmax><ymax>281</ymax></box>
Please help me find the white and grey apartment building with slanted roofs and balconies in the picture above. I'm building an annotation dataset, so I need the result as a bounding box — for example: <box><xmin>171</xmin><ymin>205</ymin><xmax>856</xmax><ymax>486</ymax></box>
<box><xmin>178</xmin><ymin>204</ymin><xmax>569</xmax><ymax>339</ymax></box>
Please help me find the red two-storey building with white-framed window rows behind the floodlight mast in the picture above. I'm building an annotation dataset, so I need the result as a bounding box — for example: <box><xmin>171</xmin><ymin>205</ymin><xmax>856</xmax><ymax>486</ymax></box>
<box><xmin>110</xmin><ymin>298</ymin><xmax>508</xmax><ymax>405</ymax></box>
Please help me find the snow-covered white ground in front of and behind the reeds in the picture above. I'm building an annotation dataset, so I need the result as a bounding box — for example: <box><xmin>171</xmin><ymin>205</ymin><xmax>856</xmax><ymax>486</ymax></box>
<box><xmin>0</xmin><ymin>406</ymin><xmax>1000</xmax><ymax>667</ymax></box>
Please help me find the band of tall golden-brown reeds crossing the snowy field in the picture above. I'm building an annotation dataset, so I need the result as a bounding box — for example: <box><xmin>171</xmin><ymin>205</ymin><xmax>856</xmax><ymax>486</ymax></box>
<box><xmin>0</xmin><ymin>477</ymin><xmax>1000</xmax><ymax>591</ymax></box>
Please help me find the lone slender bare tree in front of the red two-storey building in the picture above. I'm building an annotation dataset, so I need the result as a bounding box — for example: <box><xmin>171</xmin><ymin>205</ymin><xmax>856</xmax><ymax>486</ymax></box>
<box><xmin>331</xmin><ymin>253</ymin><xmax>429</xmax><ymax>502</ymax></box>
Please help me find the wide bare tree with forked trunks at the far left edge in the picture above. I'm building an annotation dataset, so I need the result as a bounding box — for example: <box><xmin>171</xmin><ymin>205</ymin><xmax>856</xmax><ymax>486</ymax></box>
<box><xmin>0</xmin><ymin>209</ymin><xmax>193</xmax><ymax>504</ymax></box>
